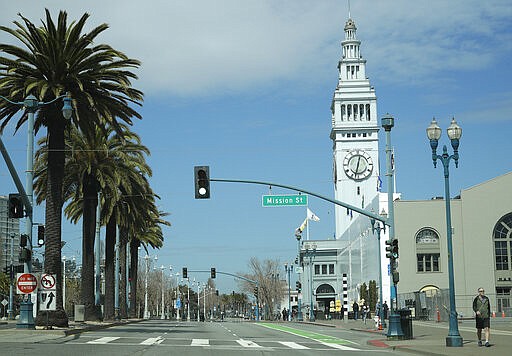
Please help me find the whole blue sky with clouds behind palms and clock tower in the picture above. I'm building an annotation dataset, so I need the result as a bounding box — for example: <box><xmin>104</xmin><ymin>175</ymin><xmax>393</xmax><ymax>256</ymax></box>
<box><xmin>0</xmin><ymin>0</ymin><xmax>512</xmax><ymax>292</ymax></box>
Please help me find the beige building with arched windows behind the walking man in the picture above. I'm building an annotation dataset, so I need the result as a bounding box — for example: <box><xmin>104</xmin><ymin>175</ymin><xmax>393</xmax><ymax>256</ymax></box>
<box><xmin>394</xmin><ymin>172</ymin><xmax>512</xmax><ymax>319</ymax></box>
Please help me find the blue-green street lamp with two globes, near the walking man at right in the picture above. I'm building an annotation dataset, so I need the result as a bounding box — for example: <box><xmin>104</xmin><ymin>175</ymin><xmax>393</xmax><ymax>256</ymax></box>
<box><xmin>427</xmin><ymin>118</ymin><xmax>462</xmax><ymax>347</ymax></box>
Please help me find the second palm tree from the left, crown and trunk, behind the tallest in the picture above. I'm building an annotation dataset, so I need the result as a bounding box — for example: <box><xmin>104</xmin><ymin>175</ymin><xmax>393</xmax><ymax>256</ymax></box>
<box><xmin>34</xmin><ymin>125</ymin><xmax>156</xmax><ymax>320</ymax></box>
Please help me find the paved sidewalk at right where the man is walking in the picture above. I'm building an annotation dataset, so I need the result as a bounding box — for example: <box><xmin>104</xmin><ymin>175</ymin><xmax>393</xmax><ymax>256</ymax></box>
<box><xmin>308</xmin><ymin>318</ymin><xmax>512</xmax><ymax>356</ymax></box>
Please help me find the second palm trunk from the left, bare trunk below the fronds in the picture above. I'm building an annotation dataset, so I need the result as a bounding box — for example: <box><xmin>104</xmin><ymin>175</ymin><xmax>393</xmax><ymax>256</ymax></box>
<box><xmin>80</xmin><ymin>176</ymin><xmax>100</xmax><ymax>320</ymax></box>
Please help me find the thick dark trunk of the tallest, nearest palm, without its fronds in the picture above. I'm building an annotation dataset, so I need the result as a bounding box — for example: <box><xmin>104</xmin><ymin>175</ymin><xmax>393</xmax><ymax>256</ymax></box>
<box><xmin>35</xmin><ymin>118</ymin><xmax>68</xmax><ymax>327</ymax></box>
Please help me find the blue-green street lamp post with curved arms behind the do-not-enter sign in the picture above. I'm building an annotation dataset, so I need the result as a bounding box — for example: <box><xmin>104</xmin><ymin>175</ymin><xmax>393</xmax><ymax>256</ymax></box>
<box><xmin>0</xmin><ymin>93</ymin><xmax>73</xmax><ymax>329</ymax></box>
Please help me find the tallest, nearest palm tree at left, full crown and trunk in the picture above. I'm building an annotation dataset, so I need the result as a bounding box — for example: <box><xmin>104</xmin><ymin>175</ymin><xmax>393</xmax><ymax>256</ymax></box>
<box><xmin>0</xmin><ymin>10</ymin><xmax>143</xmax><ymax>326</ymax></box>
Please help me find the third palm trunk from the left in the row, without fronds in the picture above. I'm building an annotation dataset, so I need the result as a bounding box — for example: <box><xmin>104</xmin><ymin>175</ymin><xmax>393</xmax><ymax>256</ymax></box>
<box><xmin>103</xmin><ymin>216</ymin><xmax>116</xmax><ymax>320</ymax></box>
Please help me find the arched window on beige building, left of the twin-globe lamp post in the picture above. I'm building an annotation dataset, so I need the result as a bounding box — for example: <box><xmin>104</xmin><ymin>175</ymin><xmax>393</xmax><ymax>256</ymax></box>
<box><xmin>416</xmin><ymin>227</ymin><xmax>440</xmax><ymax>273</ymax></box>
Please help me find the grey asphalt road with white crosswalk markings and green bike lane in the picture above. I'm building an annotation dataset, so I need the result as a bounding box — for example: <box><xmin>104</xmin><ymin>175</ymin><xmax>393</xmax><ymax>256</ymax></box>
<box><xmin>0</xmin><ymin>320</ymin><xmax>422</xmax><ymax>356</ymax></box>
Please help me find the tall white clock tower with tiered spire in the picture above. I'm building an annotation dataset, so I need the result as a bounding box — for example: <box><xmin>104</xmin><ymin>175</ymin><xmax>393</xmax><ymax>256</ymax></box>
<box><xmin>331</xmin><ymin>16</ymin><xmax>379</xmax><ymax>239</ymax></box>
